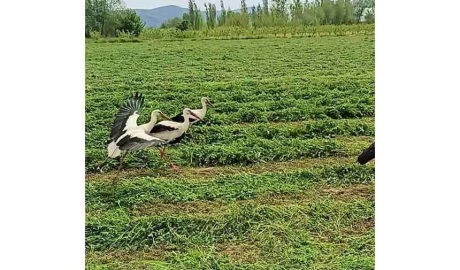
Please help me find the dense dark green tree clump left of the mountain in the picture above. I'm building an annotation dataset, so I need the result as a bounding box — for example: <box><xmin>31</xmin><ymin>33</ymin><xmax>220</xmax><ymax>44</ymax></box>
<box><xmin>85</xmin><ymin>0</ymin><xmax>145</xmax><ymax>37</ymax></box>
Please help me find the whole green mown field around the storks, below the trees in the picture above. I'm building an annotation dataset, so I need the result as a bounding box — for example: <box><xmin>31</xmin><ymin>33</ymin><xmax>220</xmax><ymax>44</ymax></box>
<box><xmin>86</xmin><ymin>34</ymin><xmax>375</xmax><ymax>269</ymax></box>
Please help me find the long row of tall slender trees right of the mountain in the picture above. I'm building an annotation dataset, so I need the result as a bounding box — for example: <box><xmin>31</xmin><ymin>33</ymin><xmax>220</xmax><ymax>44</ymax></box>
<box><xmin>161</xmin><ymin>0</ymin><xmax>375</xmax><ymax>31</ymax></box>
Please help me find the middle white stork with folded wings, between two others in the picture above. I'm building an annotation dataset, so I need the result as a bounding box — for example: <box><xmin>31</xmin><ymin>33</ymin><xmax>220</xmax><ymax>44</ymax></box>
<box><xmin>149</xmin><ymin>108</ymin><xmax>201</xmax><ymax>170</ymax></box>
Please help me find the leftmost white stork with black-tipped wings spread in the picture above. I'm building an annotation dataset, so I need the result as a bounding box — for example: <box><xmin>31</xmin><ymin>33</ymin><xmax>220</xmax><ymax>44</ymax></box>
<box><xmin>107</xmin><ymin>93</ymin><xmax>169</xmax><ymax>170</ymax></box>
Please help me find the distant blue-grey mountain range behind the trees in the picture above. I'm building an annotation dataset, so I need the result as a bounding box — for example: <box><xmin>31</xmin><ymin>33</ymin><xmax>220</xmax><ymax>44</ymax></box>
<box><xmin>135</xmin><ymin>5</ymin><xmax>244</xmax><ymax>27</ymax></box>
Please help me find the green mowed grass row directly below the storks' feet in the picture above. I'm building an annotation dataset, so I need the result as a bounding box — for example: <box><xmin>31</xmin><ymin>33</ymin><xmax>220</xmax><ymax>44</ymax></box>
<box><xmin>86</xmin><ymin>164</ymin><xmax>374</xmax><ymax>211</ymax></box>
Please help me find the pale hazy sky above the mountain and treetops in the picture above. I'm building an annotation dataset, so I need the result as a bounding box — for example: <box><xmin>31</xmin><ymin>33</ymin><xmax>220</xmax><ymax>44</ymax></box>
<box><xmin>124</xmin><ymin>0</ymin><xmax>264</xmax><ymax>10</ymax></box>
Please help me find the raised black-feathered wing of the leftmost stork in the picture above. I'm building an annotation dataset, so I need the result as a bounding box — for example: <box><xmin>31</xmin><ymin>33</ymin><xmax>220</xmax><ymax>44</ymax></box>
<box><xmin>110</xmin><ymin>93</ymin><xmax>144</xmax><ymax>141</ymax></box>
